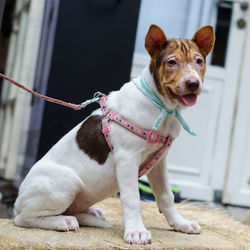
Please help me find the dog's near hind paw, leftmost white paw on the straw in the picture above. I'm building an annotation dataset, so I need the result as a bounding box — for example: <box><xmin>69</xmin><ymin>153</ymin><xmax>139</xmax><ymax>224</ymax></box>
<box><xmin>56</xmin><ymin>216</ymin><xmax>79</xmax><ymax>232</ymax></box>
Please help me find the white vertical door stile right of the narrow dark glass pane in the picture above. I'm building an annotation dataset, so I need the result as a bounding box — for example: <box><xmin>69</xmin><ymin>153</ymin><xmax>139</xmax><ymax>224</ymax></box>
<box><xmin>211</xmin><ymin>2</ymin><xmax>248</xmax><ymax>191</ymax></box>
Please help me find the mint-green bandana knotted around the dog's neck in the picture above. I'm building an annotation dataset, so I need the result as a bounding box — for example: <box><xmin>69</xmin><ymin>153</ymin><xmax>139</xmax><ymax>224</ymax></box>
<box><xmin>132</xmin><ymin>75</ymin><xmax>197</xmax><ymax>136</ymax></box>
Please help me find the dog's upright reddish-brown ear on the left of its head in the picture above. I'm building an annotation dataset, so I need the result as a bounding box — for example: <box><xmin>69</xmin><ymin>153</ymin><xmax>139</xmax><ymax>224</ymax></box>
<box><xmin>145</xmin><ymin>24</ymin><xmax>168</xmax><ymax>57</ymax></box>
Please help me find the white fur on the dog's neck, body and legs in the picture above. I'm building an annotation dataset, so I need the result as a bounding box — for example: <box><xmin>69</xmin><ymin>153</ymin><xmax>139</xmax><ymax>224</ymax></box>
<box><xmin>14</xmin><ymin>68</ymin><xmax>200</xmax><ymax>244</ymax></box>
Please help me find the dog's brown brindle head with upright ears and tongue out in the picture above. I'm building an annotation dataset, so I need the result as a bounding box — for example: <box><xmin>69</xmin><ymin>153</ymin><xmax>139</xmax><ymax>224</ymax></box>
<box><xmin>145</xmin><ymin>25</ymin><xmax>215</xmax><ymax>107</ymax></box>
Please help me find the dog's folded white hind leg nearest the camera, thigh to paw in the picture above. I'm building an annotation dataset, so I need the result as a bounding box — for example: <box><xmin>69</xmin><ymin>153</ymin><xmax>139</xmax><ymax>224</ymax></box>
<box><xmin>14</xmin><ymin>166</ymin><xmax>83</xmax><ymax>231</ymax></box>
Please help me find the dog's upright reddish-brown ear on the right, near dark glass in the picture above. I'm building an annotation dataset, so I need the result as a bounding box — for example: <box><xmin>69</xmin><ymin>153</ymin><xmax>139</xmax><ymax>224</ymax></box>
<box><xmin>192</xmin><ymin>25</ymin><xmax>215</xmax><ymax>56</ymax></box>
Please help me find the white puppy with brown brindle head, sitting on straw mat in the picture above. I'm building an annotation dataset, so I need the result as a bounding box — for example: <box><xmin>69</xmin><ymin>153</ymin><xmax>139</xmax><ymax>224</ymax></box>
<box><xmin>14</xmin><ymin>25</ymin><xmax>215</xmax><ymax>244</ymax></box>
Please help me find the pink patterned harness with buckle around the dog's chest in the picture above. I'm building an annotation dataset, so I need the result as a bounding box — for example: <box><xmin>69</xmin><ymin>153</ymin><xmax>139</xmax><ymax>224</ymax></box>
<box><xmin>98</xmin><ymin>96</ymin><xmax>175</xmax><ymax>177</ymax></box>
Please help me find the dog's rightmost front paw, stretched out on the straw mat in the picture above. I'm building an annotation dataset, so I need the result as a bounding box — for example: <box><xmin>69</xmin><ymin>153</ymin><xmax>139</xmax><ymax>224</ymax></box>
<box><xmin>169</xmin><ymin>219</ymin><xmax>201</xmax><ymax>234</ymax></box>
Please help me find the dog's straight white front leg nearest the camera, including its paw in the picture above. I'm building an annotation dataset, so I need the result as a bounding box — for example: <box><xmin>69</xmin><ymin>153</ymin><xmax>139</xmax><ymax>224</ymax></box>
<box><xmin>114</xmin><ymin>151</ymin><xmax>151</xmax><ymax>244</ymax></box>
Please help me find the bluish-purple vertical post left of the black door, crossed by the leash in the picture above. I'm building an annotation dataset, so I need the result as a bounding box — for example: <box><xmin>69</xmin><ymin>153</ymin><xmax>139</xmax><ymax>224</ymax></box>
<box><xmin>19</xmin><ymin>0</ymin><xmax>60</xmax><ymax>182</ymax></box>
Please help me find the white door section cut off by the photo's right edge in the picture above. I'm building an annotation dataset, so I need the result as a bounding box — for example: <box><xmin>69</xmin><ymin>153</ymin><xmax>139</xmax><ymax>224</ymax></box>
<box><xmin>223</xmin><ymin>0</ymin><xmax>250</xmax><ymax>206</ymax></box>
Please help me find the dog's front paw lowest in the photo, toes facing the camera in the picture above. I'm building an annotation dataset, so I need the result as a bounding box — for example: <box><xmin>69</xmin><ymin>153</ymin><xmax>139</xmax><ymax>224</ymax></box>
<box><xmin>124</xmin><ymin>229</ymin><xmax>152</xmax><ymax>244</ymax></box>
